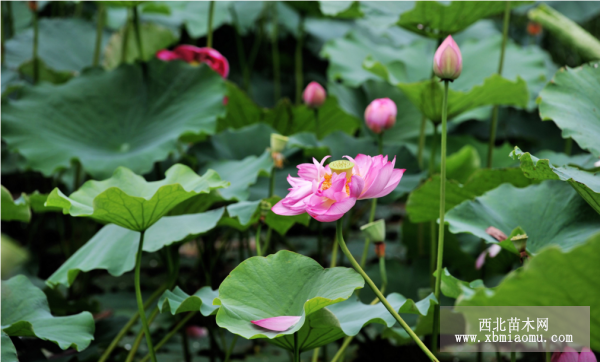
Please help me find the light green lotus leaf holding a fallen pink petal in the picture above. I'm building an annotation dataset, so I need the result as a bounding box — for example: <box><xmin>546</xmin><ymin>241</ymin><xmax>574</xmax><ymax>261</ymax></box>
<box><xmin>214</xmin><ymin>250</ymin><xmax>364</xmax><ymax>339</ymax></box>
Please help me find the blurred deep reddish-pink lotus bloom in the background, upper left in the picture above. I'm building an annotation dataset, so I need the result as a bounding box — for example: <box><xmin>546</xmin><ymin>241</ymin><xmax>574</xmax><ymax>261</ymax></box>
<box><xmin>156</xmin><ymin>45</ymin><xmax>229</xmax><ymax>78</ymax></box>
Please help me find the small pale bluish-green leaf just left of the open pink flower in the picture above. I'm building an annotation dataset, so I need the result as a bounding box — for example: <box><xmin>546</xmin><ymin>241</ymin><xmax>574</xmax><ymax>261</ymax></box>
<box><xmin>205</xmin><ymin>151</ymin><xmax>273</xmax><ymax>201</ymax></box>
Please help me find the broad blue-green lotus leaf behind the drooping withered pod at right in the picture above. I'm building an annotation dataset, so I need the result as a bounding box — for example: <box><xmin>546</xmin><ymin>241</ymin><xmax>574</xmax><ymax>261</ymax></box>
<box><xmin>446</xmin><ymin>181</ymin><xmax>600</xmax><ymax>254</ymax></box>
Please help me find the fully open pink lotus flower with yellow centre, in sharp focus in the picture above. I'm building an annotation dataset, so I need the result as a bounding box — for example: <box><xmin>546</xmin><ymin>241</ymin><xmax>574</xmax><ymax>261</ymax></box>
<box><xmin>272</xmin><ymin>154</ymin><xmax>405</xmax><ymax>222</ymax></box>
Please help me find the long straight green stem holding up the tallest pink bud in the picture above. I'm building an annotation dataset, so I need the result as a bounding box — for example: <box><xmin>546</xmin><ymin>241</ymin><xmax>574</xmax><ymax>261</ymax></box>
<box><xmin>432</xmin><ymin>80</ymin><xmax>450</xmax><ymax>351</ymax></box>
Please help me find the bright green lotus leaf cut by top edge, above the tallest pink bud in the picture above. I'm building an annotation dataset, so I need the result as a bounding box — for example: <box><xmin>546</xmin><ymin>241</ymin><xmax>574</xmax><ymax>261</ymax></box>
<box><xmin>398</xmin><ymin>1</ymin><xmax>526</xmax><ymax>38</ymax></box>
